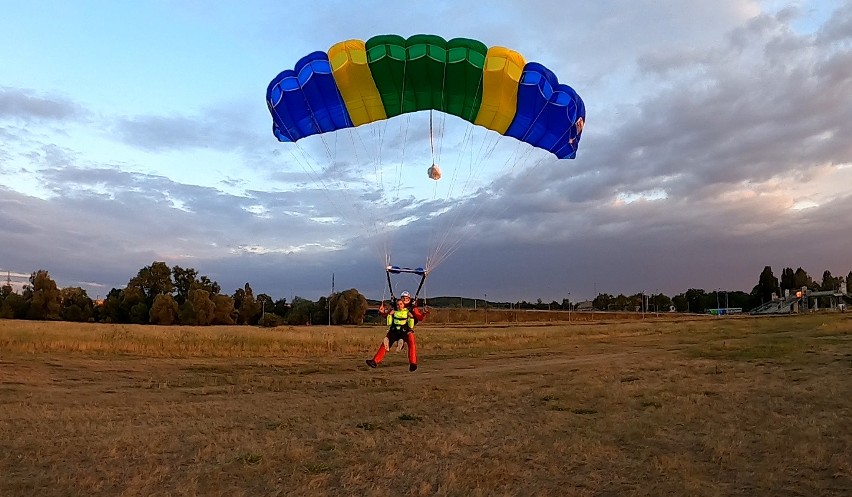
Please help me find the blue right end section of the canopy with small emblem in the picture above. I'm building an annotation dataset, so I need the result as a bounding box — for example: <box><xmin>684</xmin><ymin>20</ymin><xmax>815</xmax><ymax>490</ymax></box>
<box><xmin>506</xmin><ymin>62</ymin><xmax>582</xmax><ymax>159</ymax></box>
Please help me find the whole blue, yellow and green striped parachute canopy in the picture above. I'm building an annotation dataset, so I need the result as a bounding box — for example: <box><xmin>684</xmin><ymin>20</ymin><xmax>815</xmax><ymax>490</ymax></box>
<box><xmin>266</xmin><ymin>35</ymin><xmax>586</xmax><ymax>158</ymax></box>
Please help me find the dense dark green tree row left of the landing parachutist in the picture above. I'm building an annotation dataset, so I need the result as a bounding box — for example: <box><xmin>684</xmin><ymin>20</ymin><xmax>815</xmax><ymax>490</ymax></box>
<box><xmin>0</xmin><ymin>262</ymin><xmax>367</xmax><ymax>326</ymax></box>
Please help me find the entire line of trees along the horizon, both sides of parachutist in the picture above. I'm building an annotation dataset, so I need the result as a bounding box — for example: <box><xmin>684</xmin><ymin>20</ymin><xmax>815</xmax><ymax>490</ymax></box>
<box><xmin>0</xmin><ymin>262</ymin><xmax>852</xmax><ymax>326</ymax></box>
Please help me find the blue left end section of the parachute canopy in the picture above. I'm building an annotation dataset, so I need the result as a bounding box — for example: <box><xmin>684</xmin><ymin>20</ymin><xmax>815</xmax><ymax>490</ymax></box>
<box><xmin>266</xmin><ymin>52</ymin><xmax>352</xmax><ymax>142</ymax></box>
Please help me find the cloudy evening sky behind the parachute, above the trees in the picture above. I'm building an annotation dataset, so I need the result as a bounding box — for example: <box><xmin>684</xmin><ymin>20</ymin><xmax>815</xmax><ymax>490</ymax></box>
<box><xmin>0</xmin><ymin>0</ymin><xmax>852</xmax><ymax>301</ymax></box>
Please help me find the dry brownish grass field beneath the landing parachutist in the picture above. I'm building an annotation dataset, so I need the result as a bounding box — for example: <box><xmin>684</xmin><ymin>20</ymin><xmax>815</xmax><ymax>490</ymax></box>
<box><xmin>0</xmin><ymin>313</ymin><xmax>852</xmax><ymax>497</ymax></box>
